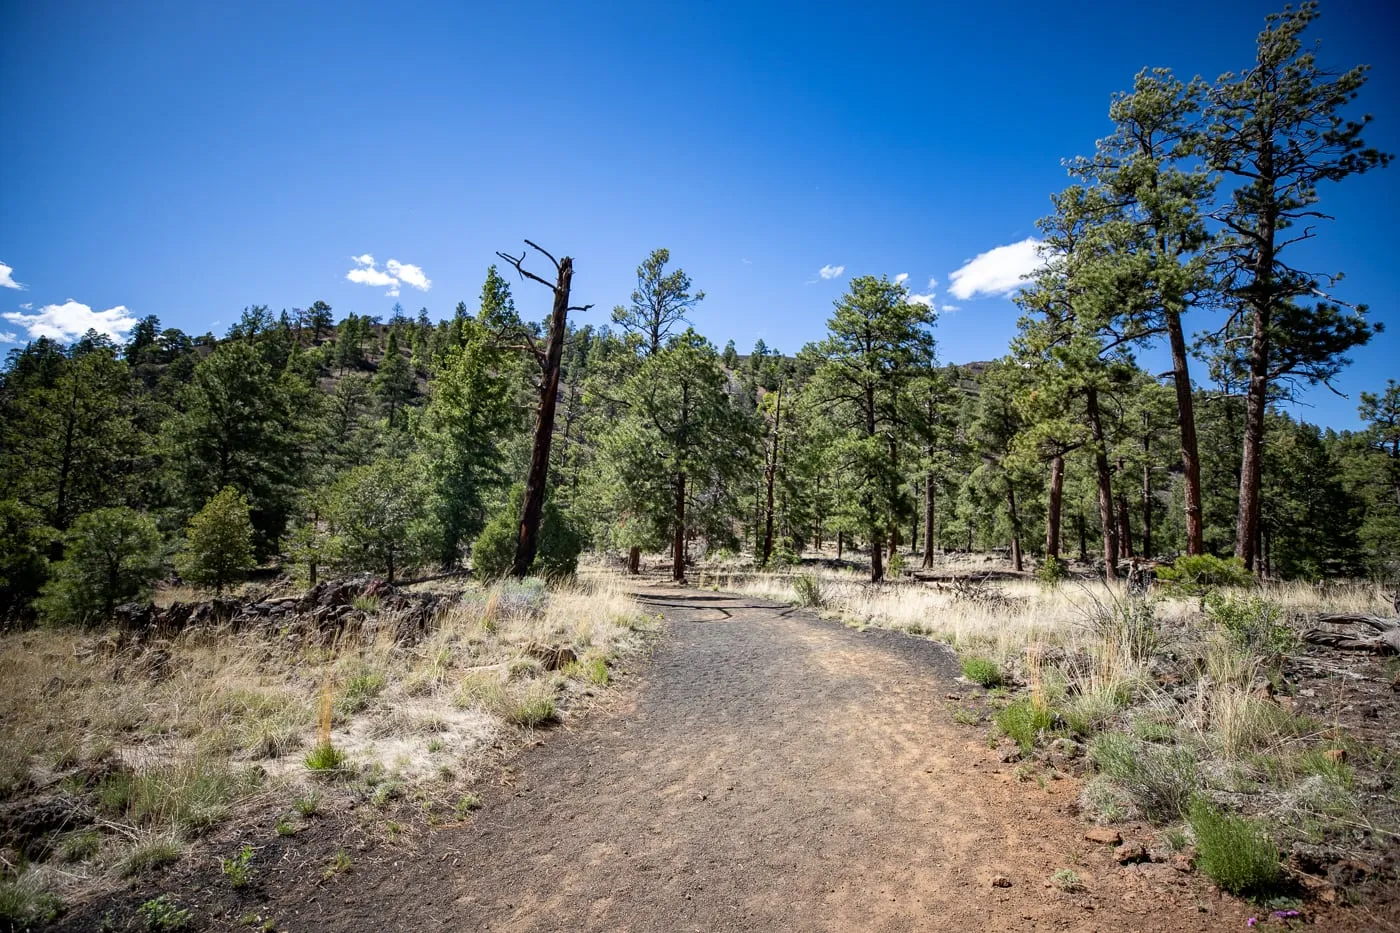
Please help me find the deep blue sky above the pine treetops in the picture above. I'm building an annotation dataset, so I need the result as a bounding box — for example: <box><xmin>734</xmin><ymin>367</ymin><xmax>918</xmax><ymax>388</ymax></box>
<box><xmin>0</xmin><ymin>0</ymin><xmax>1400</xmax><ymax>427</ymax></box>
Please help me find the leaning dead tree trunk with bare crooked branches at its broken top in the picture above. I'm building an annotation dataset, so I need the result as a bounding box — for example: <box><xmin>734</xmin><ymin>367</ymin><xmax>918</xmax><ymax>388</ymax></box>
<box><xmin>496</xmin><ymin>240</ymin><xmax>594</xmax><ymax>579</ymax></box>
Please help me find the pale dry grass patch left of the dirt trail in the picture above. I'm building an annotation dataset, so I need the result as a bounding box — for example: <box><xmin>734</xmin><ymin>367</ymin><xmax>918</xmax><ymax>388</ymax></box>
<box><xmin>0</xmin><ymin>571</ymin><xmax>644</xmax><ymax>895</ymax></box>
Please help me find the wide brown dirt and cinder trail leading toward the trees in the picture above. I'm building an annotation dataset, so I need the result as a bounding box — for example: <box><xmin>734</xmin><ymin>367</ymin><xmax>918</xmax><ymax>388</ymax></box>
<box><xmin>289</xmin><ymin>588</ymin><xmax>1247</xmax><ymax>932</ymax></box>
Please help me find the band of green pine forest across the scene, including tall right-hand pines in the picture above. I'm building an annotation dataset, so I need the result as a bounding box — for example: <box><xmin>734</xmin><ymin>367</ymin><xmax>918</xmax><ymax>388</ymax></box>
<box><xmin>0</xmin><ymin>4</ymin><xmax>1400</xmax><ymax>619</ymax></box>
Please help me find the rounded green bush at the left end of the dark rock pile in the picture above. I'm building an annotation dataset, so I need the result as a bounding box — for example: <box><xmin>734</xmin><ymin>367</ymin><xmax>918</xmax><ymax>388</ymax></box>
<box><xmin>39</xmin><ymin>507</ymin><xmax>162</xmax><ymax>625</ymax></box>
